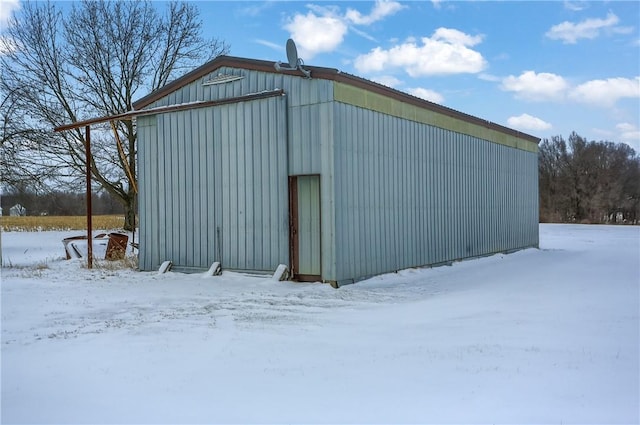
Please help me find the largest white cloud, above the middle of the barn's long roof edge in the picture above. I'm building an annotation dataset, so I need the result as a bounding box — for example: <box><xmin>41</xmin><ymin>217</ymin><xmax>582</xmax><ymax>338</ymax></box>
<box><xmin>354</xmin><ymin>28</ymin><xmax>487</xmax><ymax>77</ymax></box>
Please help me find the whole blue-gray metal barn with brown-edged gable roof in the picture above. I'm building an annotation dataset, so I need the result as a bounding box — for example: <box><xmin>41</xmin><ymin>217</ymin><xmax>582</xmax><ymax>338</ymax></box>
<box><xmin>134</xmin><ymin>56</ymin><xmax>539</xmax><ymax>286</ymax></box>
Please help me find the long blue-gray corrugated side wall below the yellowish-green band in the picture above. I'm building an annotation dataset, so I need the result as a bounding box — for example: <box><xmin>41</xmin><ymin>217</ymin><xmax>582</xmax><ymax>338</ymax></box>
<box><xmin>334</xmin><ymin>102</ymin><xmax>538</xmax><ymax>281</ymax></box>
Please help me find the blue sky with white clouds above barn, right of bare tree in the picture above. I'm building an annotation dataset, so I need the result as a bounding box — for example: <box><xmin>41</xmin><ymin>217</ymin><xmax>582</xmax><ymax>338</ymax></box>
<box><xmin>0</xmin><ymin>0</ymin><xmax>640</xmax><ymax>152</ymax></box>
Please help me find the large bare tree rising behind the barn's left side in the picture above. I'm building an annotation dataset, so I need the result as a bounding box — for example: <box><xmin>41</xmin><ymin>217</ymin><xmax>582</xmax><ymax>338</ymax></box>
<box><xmin>0</xmin><ymin>1</ymin><xmax>229</xmax><ymax>230</ymax></box>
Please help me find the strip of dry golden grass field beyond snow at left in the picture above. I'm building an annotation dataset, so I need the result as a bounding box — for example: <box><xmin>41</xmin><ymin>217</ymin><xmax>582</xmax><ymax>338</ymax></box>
<box><xmin>0</xmin><ymin>215</ymin><xmax>124</xmax><ymax>232</ymax></box>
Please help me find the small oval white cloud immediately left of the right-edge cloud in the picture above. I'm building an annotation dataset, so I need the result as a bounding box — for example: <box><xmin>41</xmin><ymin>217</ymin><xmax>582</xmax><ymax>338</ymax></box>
<box><xmin>500</xmin><ymin>71</ymin><xmax>569</xmax><ymax>101</ymax></box>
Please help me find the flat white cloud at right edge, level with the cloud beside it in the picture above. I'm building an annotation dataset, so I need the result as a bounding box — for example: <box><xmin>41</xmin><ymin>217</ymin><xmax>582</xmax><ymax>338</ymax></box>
<box><xmin>569</xmin><ymin>77</ymin><xmax>640</xmax><ymax>107</ymax></box>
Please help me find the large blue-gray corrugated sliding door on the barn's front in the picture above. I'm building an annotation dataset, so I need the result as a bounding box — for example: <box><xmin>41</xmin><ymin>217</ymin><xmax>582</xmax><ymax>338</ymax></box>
<box><xmin>139</xmin><ymin>98</ymin><xmax>289</xmax><ymax>270</ymax></box>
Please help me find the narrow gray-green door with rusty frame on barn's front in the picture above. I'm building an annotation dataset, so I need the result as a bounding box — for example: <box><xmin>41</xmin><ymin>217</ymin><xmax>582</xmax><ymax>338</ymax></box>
<box><xmin>289</xmin><ymin>175</ymin><xmax>322</xmax><ymax>282</ymax></box>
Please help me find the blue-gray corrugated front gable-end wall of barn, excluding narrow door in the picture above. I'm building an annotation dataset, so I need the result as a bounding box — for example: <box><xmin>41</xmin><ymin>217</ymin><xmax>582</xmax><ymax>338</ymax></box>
<box><xmin>137</xmin><ymin>67</ymin><xmax>333</xmax><ymax>273</ymax></box>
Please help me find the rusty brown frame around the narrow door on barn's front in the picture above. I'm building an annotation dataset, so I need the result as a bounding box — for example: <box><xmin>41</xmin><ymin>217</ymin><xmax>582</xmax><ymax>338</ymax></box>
<box><xmin>289</xmin><ymin>174</ymin><xmax>322</xmax><ymax>282</ymax></box>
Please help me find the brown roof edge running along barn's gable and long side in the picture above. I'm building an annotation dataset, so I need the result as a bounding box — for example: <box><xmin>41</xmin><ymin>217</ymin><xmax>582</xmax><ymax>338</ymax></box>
<box><xmin>133</xmin><ymin>56</ymin><xmax>540</xmax><ymax>144</ymax></box>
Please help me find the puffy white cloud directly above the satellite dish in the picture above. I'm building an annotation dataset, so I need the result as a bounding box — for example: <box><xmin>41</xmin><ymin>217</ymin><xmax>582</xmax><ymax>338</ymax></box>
<box><xmin>284</xmin><ymin>11</ymin><xmax>347</xmax><ymax>60</ymax></box>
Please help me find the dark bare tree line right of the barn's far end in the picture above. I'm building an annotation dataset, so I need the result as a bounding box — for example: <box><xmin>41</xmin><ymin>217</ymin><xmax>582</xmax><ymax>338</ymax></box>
<box><xmin>538</xmin><ymin>132</ymin><xmax>640</xmax><ymax>224</ymax></box>
